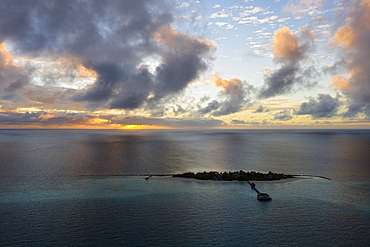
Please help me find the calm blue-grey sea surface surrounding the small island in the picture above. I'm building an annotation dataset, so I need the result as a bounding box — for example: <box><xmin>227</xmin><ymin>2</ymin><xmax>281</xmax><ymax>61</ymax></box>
<box><xmin>0</xmin><ymin>130</ymin><xmax>370</xmax><ymax>246</ymax></box>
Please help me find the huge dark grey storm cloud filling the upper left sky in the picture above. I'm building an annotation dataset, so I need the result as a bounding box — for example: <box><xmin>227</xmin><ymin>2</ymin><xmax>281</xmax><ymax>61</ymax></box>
<box><xmin>0</xmin><ymin>0</ymin><xmax>216</xmax><ymax>109</ymax></box>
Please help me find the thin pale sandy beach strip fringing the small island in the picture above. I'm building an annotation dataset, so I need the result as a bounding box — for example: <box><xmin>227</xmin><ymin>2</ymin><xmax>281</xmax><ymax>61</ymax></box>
<box><xmin>143</xmin><ymin>176</ymin><xmax>310</xmax><ymax>184</ymax></box>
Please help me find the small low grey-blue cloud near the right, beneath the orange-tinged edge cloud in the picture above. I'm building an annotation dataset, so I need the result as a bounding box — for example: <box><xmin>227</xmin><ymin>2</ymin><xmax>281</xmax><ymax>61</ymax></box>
<box><xmin>295</xmin><ymin>94</ymin><xmax>341</xmax><ymax>119</ymax></box>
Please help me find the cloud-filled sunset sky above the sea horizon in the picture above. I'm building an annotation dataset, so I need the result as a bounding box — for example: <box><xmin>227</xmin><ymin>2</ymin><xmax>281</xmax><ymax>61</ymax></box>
<box><xmin>0</xmin><ymin>0</ymin><xmax>370</xmax><ymax>129</ymax></box>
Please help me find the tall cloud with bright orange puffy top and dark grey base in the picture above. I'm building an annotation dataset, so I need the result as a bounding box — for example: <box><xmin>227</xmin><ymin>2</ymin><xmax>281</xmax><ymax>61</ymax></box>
<box><xmin>259</xmin><ymin>27</ymin><xmax>318</xmax><ymax>98</ymax></box>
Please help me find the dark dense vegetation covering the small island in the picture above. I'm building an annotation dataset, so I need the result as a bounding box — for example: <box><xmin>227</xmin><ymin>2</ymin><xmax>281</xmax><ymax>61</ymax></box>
<box><xmin>173</xmin><ymin>170</ymin><xmax>293</xmax><ymax>181</ymax></box>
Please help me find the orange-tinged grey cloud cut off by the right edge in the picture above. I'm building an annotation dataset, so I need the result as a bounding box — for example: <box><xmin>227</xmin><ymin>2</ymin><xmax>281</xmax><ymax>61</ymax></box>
<box><xmin>326</xmin><ymin>0</ymin><xmax>370</xmax><ymax>108</ymax></box>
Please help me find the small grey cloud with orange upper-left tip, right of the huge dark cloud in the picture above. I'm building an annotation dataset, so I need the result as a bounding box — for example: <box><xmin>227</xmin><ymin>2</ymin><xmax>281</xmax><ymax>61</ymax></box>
<box><xmin>198</xmin><ymin>73</ymin><xmax>253</xmax><ymax>116</ymax></box>
